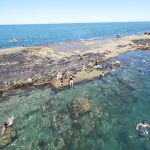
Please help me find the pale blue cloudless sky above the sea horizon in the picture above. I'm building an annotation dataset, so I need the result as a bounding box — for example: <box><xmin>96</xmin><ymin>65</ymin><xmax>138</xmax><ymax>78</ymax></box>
<box><xmin>0</xmin><ymin>0</ymin><xmax>150</xmax><ymax>25</ymax></box>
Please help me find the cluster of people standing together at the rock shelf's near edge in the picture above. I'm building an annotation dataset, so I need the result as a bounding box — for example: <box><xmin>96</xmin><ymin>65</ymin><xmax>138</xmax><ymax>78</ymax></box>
<box><xmin>57</xmin><ymin>72</ymin><xmax>74</xmax><ymax>87</ymax></box>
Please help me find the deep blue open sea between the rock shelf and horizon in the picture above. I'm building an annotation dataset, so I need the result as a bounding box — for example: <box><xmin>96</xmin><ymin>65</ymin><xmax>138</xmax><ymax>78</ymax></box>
<box><xmin>0</xmin><ymin>22</ymin><xmax>150</xmax><ymax>49</ymax></box>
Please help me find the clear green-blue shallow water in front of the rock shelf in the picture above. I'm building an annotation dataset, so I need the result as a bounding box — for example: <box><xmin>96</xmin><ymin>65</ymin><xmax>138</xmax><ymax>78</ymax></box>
<box><xmin>0</xmin><ymin>51</ymin><xmax>150</xmax><ymax>150</ymax></box>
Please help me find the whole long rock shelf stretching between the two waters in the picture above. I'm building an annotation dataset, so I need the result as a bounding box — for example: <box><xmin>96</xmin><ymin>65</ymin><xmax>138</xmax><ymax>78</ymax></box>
<box><xmin>0</xmin><ymin>34</ymin><xmax>150</xmax><ymax>96</ymax></box>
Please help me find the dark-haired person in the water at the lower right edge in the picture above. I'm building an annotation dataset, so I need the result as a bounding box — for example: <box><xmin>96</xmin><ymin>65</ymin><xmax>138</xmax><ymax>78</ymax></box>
<box><xmin>136</xmin><ymin>120</ymin><xmax>150</xmax><ymax>136</ymax></box>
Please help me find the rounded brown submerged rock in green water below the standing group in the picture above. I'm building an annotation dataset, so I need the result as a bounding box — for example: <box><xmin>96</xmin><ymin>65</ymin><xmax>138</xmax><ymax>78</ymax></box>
<box><xmin>68</xmin><ymin>97</ymin><xmax>92</xmax><ymax>119</ymax></box>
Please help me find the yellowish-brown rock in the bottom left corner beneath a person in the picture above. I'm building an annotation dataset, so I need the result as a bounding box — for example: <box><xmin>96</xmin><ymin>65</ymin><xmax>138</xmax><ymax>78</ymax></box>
<box><xmin>0</xmin><ymin>128</ymin><xmax>17</xmax><ymax>149</ymax></box>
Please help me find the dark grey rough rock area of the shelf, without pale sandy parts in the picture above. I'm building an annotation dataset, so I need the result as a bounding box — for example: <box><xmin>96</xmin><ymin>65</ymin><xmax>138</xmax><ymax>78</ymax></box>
<box><xmin>0</xmin><ymin>47</ymin><xmax>119</xmax><ymax>96</ymax></box>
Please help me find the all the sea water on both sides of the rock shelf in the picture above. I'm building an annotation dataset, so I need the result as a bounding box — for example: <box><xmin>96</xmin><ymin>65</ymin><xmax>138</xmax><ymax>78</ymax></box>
<box><xmin>0</xmin><ymin>23</ymin><xmax>150</xmax><ymax>150</ymax></box>
